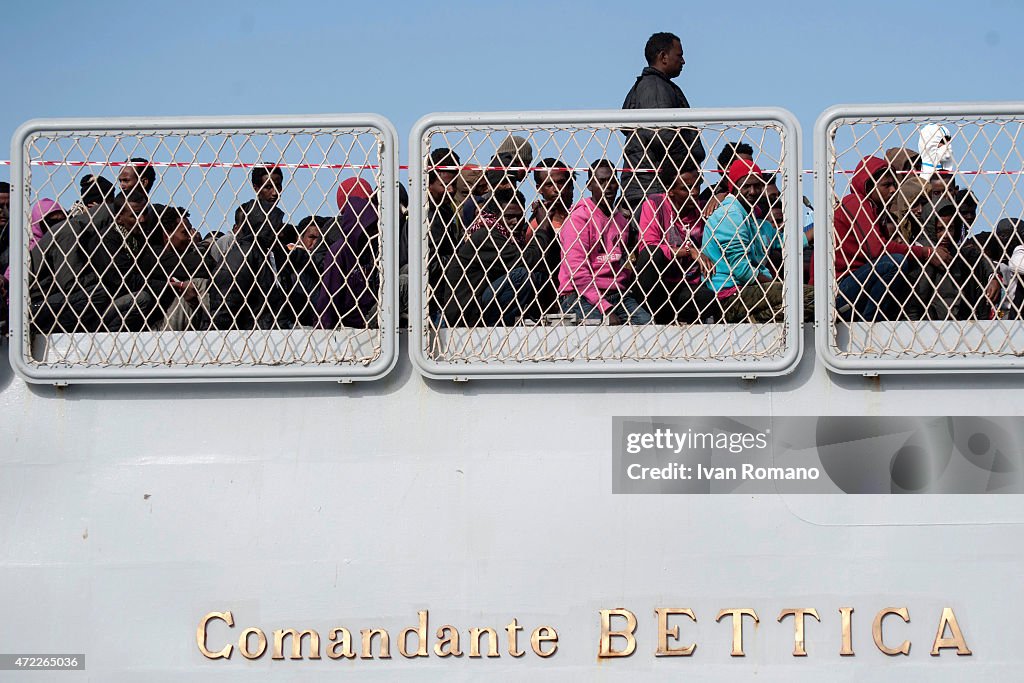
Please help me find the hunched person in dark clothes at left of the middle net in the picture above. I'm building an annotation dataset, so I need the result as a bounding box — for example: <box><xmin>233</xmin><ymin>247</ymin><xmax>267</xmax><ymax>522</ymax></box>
<box><xmin>443</xmin><ymin>190</ymin><xmax>554</xmax><ymax>328</ymax></box>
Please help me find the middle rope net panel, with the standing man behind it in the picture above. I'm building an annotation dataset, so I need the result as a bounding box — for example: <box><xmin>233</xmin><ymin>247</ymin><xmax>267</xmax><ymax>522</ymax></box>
<box><xmin>412</xmin><ymin>122</ymin><xmax>811</xmax><ymax>366</ymax></box>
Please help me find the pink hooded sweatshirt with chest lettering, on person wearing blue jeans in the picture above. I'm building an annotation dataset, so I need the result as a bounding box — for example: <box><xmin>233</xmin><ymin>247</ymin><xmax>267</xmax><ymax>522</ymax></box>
<box><xmin>558</xmin><ymin>198</ymin><xmax>630</xmax><ymax>313</ymax></box>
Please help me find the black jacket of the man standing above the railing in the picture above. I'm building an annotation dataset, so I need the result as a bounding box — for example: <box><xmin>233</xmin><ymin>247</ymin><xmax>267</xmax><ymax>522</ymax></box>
<box><xmin>623</xmin><ymin>67</ymin><xmax>707</xmax><ymax>206</ymax></box>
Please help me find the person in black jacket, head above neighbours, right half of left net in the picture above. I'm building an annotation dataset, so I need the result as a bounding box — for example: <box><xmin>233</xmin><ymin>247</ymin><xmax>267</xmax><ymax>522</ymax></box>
<box><xmin>210</xmin><ymin>164</ymin><xmax>285</xmax><ymax>330</ymax></box>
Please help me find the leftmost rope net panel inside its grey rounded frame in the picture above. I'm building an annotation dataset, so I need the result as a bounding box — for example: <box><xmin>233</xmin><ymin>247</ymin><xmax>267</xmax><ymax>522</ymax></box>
<box><xmin>20</xmin><ymin>128</ymin><xmax>384</xmax><ymax>368</ymax></box>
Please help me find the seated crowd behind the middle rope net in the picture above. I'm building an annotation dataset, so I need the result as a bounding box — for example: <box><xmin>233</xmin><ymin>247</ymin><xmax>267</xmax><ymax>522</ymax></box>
<box><xmin>427</xmin><ymin>136</ymin><xmax>813</xmax><ymax>327</ymax></box>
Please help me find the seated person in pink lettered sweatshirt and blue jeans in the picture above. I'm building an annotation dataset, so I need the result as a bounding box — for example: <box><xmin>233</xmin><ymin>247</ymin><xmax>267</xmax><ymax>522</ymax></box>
<box><xmin>558</xmin><ymin>159</ymin><xmax>650</xmax><ymax>325</ymax></box>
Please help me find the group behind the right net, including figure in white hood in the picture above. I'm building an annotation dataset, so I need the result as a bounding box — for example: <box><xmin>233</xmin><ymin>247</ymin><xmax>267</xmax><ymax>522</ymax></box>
<box><xmin>834</xmin><ymin>133</ymin><xmax>1024</xmax><ymax>321</ymax></box>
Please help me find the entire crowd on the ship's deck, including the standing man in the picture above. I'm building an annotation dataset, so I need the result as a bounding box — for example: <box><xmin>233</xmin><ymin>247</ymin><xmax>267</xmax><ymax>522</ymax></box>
<box><xmin>0</xmin><ymin>33</ymin><xmax>1024</xmax><ymax>334</ymax></box>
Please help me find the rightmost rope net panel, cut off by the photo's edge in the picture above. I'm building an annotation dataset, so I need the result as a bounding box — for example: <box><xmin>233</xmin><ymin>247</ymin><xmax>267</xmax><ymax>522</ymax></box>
<box><xmin>819</xmin><ymin>116</ymin><xmax>1024</xmax><ymax>359</ymax></box>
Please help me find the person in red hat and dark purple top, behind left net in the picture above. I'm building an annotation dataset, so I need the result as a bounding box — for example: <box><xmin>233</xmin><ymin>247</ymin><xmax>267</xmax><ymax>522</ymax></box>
<box><xmin>315</xmin><ymin>178</ymin><xmax>380</xmax><ymax>330</ymax></box>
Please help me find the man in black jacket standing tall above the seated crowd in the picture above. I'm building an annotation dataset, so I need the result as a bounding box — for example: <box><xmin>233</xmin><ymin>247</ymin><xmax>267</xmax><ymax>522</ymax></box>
<box><xmin>623</xmin><ymin>33</ymin><xmax>706</xmax><ymax>213</ymax></box>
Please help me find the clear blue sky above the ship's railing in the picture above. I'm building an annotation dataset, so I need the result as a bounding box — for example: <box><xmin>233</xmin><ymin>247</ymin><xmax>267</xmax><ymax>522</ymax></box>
<box><xmin>0</xmin><ymin>0</ymin><xmax>1024</xmax><ymax>163</ymax></box>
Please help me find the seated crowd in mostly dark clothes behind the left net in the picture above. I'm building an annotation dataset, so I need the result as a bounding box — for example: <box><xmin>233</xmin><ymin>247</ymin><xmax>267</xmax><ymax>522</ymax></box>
<box><xmin>5</xmin><ymin>164</ymin><xmax>391</xmax><ymax>334</ymax></box>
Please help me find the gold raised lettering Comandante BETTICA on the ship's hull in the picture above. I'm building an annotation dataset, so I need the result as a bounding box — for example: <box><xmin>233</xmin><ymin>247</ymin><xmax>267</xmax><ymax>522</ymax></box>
<box><xmin>196</xmin><ymin>606</ymin><xmax>972</xmax><ymax>659</ymax></box>
